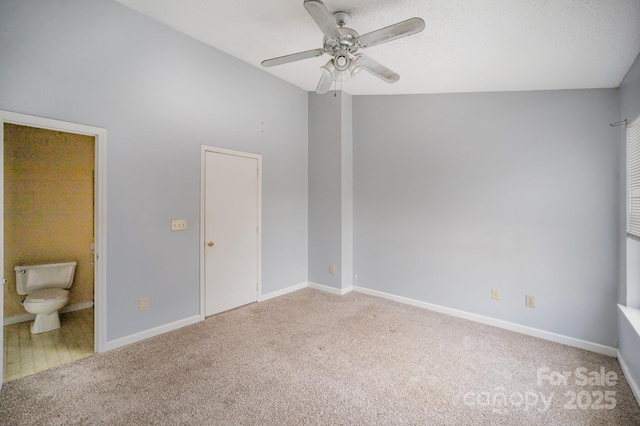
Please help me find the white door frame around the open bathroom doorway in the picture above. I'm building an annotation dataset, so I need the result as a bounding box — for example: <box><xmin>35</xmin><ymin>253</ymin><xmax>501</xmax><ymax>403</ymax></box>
<box><xmin>0</xmin><ymin>110</ymin><xmax>107</xmax><ymax>356</ymax></box>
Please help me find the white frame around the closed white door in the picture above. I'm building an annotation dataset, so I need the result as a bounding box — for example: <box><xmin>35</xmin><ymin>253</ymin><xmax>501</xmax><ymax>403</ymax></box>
<box><xmin>200</xmin><ymin>145</ymin><xmax>262</xmax><ymax>320</ymax></box>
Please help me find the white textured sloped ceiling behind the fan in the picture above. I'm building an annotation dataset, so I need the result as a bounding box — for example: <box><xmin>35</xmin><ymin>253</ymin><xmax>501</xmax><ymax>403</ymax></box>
<box><xmin>117</xmin><ymin>0</ymin><xmax>640</xmax><ymax>95</ymax></box>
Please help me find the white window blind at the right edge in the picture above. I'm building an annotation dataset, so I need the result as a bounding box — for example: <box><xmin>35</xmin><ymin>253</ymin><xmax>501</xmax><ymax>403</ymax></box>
<box><xmin>627</xmin><ymin>117</ymin><xmax>640</xmax><ymax>238</ymax></box>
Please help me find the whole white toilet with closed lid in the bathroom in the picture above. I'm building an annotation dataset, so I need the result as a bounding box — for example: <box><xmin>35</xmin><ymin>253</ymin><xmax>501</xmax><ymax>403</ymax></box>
<box><xmin>14</xmin><ymin>262</ymin><xmax>77</xmax><ymax>334</ymax></box>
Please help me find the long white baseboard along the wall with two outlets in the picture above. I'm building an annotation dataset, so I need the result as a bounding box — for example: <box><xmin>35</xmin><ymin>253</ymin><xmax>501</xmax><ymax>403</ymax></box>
<box><xmin>353</xmin><ymin>286</ymin><xmax>618</xmax><ymax>357</ymax></box>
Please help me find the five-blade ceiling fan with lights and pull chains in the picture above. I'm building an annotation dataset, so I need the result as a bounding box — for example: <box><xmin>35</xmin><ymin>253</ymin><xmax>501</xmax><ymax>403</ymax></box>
<box><xmin>262</xmin><ymin>0</ymin><xmax>424</xmax><ymax>94</ymax></box>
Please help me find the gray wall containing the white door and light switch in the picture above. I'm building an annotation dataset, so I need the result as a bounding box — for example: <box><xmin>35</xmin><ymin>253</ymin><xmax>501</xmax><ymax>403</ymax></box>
<box><xmin>0</xmin><ymin>0</ymin><xmax>308</xmax><ymax>341</ymax></box>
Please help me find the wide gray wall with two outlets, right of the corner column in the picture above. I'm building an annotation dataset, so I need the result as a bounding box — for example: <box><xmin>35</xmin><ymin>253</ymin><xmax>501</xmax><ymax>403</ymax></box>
<box><xmin>353</xmin><ymin>89</ymin><xmax>620</xmax><ymax>346</ymax></box>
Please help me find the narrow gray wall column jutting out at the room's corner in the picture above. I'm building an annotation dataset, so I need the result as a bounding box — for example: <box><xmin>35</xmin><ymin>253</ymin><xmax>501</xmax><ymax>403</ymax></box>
<box><xmin>309</xmin><ymin>91</ymin><xmax>353</xmax><ymax>289</ymax></box>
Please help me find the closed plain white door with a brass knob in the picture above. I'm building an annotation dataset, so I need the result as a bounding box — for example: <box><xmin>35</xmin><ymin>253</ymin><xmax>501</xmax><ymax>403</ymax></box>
<box><xmin>204</xmin><ymin>151</ymin><xmax>259</xmax><ymax>316</ymax></box>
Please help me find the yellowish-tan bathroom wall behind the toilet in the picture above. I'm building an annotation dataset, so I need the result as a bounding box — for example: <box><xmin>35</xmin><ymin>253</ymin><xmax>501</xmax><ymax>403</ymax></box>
<box><xmin>4</xmin><ymin>124</ymin><xmax>94</xmax><ymax>317</ymax></box>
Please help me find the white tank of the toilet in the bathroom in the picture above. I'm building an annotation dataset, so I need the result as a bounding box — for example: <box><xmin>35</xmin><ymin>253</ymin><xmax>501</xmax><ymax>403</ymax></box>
<box><xmin>13</xmin><ymin>262</ymin><xmax>77</xmax><ymax>295</ymax></box>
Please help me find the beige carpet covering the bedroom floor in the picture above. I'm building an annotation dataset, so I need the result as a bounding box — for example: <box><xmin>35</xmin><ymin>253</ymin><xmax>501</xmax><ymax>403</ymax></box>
<box><xmin>0</xmin><ymin>289</ymin><xmax>640</xmax><ymax>425</ymax></box>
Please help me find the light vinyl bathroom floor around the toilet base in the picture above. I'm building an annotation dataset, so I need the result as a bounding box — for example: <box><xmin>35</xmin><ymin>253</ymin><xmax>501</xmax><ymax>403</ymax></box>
<box><xmin>2</xmin><ymin>308</ymin><xmax>94</xmax><ymax>383</ymax></box>
